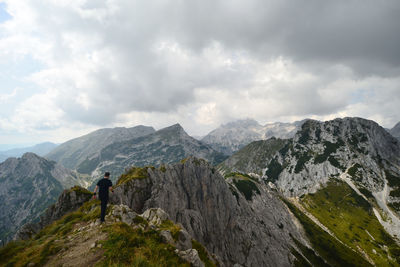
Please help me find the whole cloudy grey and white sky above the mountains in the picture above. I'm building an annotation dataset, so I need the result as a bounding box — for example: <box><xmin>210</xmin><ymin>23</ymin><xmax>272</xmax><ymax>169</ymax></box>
<box><xmin>0</xmin><ymin>0</ymin><xmax>400</xmax><ymax>147</ymax></box>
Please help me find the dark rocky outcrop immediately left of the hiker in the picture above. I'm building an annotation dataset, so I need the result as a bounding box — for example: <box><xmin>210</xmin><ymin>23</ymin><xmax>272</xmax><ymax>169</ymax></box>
<box><xmin>14</xmin><ymin>186</ymin><xmax>93</xmax><ymax>240</ymax></box>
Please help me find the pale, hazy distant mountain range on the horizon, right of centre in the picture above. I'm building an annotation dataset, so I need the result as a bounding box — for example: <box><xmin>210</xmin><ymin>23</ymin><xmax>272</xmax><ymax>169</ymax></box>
<box><xmin>201</xmin><ymin>119</ymin><xmax>305</xmax><ymax>155</ymax></box>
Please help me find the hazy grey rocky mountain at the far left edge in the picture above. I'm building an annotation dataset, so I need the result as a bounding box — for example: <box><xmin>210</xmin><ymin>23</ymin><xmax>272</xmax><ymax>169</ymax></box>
<box><xmin>0</xmin><ymin>153</ymin><xmax>87</xmax><ymax>243</ymax></box>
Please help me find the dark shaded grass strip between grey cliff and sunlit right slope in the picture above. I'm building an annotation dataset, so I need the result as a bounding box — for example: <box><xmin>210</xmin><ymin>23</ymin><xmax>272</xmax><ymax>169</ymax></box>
<box><xmin>283</xmin><ymin>199</ymin><xmax>371</xmax><ymax>266</ymax></box>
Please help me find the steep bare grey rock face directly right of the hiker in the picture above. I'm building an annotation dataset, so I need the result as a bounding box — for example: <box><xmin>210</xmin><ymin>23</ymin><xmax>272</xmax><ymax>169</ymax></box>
<box><xmin>111</xmin><ymin>158</ymin><xmax>303</xmax><ymax>266</ymax></box>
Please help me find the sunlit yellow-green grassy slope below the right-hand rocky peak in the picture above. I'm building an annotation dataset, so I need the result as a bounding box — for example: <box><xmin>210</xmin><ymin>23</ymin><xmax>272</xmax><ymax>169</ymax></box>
<box><xmin>302</xmin><ymin>180</ymin><xmax>400</xmax><ymax>266</ymax></box>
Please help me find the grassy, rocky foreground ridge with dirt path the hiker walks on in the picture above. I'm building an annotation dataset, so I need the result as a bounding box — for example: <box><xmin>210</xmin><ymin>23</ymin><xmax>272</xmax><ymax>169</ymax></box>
<box><xmin>0</xmin><ymin>187</ymin><xmax>216</xmax><ymax>267</ymax></box>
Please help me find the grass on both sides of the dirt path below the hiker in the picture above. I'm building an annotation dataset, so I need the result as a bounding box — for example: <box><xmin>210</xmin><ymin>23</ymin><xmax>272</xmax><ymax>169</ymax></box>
<box><xmin>0</xmin><ymin>200</ymin><xmax>204</xmax><ymax>266</ymax></box>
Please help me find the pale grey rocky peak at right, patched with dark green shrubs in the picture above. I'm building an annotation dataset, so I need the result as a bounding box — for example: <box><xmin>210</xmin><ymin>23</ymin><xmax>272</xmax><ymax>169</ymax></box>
<box><xmin>264</xmin><ymin>118</ymin><xmax>400</xmax><ymax>196</ymax></box>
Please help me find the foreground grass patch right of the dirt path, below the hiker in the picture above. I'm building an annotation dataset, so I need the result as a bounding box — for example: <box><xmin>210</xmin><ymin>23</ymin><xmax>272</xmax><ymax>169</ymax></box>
<box><xmin>97</xmin><ymin>222</ymin><xmax>190</xmax><ymax>266</ymax></box>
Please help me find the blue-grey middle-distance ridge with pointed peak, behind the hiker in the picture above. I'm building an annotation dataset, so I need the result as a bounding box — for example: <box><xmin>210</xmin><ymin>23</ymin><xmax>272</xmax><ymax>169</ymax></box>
<box><xmin>90</xmin><ymin>124</ymin><xmax>226</xmax><ymax>185</ymax></box>
